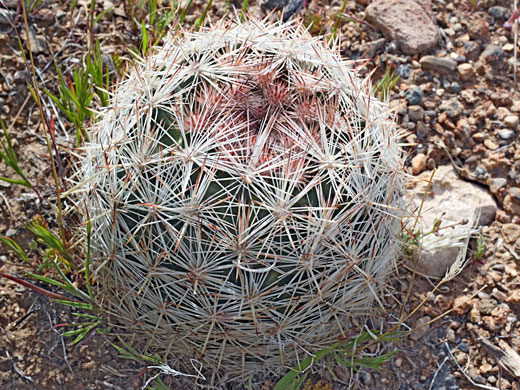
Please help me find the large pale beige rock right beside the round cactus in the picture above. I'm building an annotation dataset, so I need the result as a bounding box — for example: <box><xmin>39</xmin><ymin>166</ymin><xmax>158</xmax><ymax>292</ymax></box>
<box><xmin>408</xmin><ymin>165</ymin><xmax>497</xmax><ymax>277</ymax></box>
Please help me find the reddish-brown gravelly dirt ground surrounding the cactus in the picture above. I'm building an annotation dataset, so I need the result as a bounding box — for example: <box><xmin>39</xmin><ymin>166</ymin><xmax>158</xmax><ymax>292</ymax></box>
<box><xmin>0</xmin><ymin>0</ymin><xmax>520</xmax><ymax>390</ymax></box>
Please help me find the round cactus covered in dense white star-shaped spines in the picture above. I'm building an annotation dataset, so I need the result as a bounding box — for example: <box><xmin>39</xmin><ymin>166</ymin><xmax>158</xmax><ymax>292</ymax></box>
<box><xmin>79</xmin><ymin>20</ymin><xmax>404</xmax><ymax>374</ymax></box>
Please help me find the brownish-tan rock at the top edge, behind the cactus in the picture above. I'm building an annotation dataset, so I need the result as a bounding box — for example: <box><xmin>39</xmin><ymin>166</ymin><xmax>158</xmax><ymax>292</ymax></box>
<box><xmin>366</xmin><ymin>0</ymin><xmax>438</xmax><ymax>55</ymax></box>
